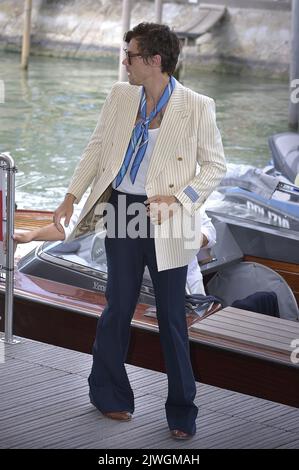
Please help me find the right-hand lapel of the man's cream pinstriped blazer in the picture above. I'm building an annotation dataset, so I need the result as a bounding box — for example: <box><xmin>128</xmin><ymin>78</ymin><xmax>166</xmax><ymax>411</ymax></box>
<box><xmin>146</xmin><ymin>82</ymin><xmax>191</xmax><ymax>182</ymax></box>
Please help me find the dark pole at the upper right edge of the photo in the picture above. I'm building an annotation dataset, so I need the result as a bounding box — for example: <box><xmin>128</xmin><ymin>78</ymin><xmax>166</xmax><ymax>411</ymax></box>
<box><xmin>289</xmin><ymin>0</ymin><xmax>299</xmax><ymax>130</ymax></box>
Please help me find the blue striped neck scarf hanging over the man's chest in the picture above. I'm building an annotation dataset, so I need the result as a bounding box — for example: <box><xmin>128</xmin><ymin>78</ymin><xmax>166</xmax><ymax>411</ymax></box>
<box><xmin>115</xmin><ymin>77</ymin><xmax>175</xmax><ymax>188</ymax></box>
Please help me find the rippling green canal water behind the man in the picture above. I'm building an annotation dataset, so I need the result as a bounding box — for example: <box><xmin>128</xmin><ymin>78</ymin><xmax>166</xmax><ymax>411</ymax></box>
<box><xmin>0</xmin><ymin>53</ymin><xmax>288</xmax><ymax>210</ymax></box>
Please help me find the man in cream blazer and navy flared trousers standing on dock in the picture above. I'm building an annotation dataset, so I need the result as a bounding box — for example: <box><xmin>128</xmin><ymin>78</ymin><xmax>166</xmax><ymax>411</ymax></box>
<box><xmin>53</xmin><ymin>23</ymin><xmax>226</xmax><ymax>439</ymax></box>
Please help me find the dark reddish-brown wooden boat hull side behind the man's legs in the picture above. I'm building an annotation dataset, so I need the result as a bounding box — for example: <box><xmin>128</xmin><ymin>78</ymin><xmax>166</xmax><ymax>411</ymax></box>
<box><xmin>0</xmin><ymin>275</ymin><xmax>299</xmax><ymax>407</ymax></box>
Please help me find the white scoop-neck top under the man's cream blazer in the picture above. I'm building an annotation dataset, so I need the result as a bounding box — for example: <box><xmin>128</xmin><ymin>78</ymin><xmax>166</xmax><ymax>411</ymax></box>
<box><xmin>112</xmin><ymin>127</ymin><xmax>160</xmax><ymax>196</ymax></box>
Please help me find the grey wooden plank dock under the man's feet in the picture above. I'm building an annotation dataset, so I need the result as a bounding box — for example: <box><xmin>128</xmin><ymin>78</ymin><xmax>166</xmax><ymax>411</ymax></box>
<box><xmin>0</xmin><ymin>339</ymin><xmax>299</xmax><ymax>449</ymax></box>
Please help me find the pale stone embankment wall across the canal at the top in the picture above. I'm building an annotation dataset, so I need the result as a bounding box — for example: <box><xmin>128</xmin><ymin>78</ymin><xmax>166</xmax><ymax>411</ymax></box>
<box><xmin>0</xmin><ymin>0</ymin><xmax>291</xmax><ymax>78</ymax></box>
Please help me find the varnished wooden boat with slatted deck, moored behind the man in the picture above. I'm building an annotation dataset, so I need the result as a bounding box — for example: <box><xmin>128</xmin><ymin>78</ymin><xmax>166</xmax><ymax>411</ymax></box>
<box><xmin>0</xmin><ymin>208</ymin><xmax>299</xmax><ymax>407</ymax></box>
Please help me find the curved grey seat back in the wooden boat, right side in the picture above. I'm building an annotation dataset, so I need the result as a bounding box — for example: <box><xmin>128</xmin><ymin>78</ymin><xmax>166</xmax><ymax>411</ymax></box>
<box><xmin>206</xmin><ymin>261</ymin><xmax>299</xmax><ymax>321</ymax></box>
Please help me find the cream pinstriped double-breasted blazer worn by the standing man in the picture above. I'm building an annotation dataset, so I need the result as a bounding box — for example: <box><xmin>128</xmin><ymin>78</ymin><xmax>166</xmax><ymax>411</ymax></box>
<box><xmin>67</xmin><ymin>78</ymin><xmax>226</xmax><ymax>271</ymax></box>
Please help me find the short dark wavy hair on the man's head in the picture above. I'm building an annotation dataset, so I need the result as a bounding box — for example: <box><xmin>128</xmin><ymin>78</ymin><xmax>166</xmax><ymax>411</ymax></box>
<box><xmin>124</xmin><ymin>23</ymin><xmax>180</xmax><ymax>75</ymax></box>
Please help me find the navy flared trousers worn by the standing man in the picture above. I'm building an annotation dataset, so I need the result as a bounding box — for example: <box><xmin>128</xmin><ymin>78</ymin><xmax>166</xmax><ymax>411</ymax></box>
<box><xmin>88</xmin><ymin>190</ymin><xmax>198</xmax><ymax>434</ymax></box>
